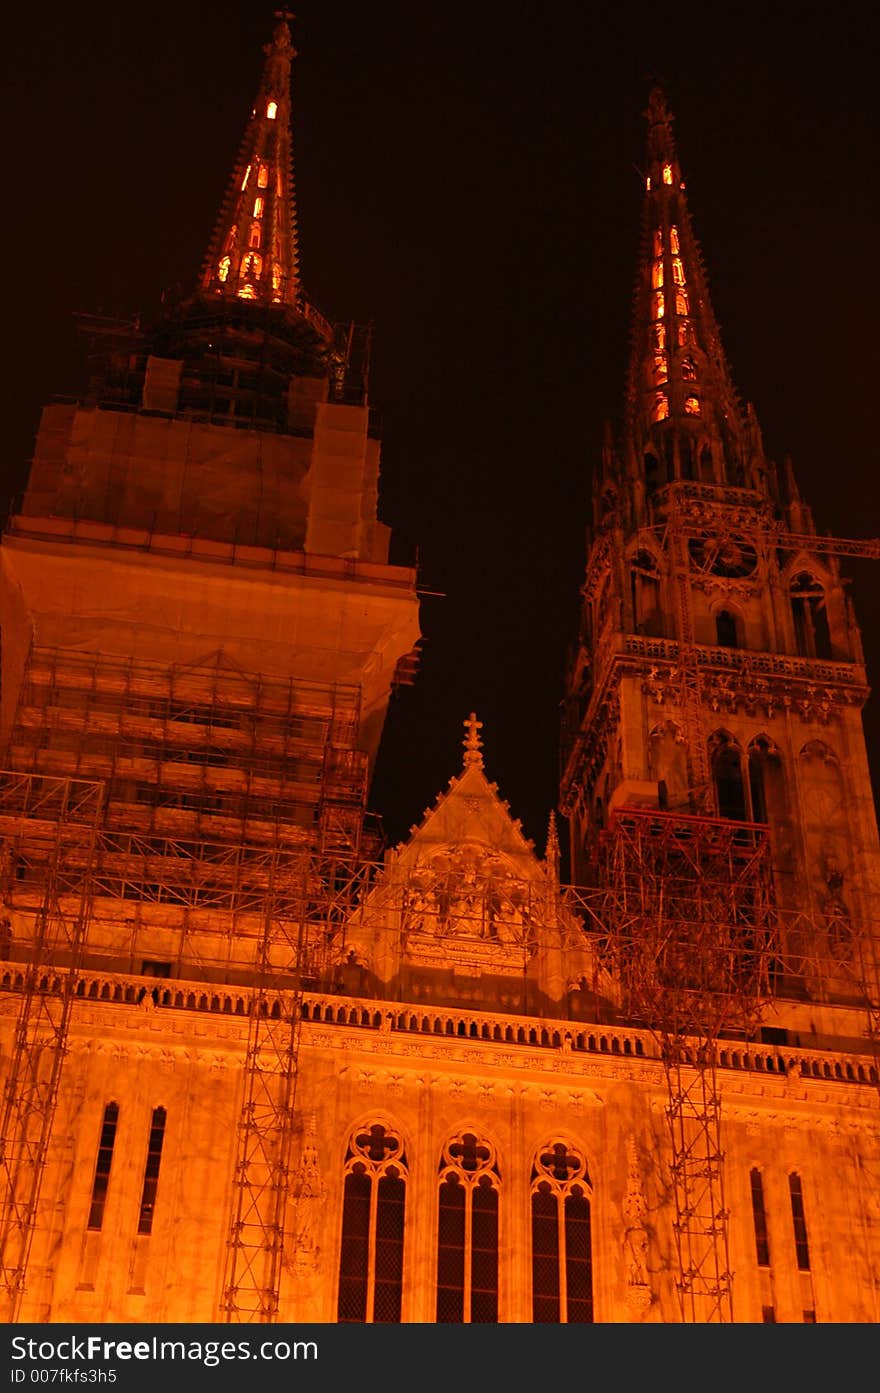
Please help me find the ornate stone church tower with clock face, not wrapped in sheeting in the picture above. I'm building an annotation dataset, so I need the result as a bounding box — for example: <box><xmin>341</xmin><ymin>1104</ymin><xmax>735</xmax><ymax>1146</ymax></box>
<box><xmin>561</xmin><ymin>89</ymin><xmax>880</xmax><ymax>999</ymax></box>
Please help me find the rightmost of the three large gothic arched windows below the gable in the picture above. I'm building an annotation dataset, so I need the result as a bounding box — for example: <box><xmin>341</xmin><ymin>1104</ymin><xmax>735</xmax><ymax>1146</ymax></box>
<box><xmin>532</xmin><ymin>1141</ymin><xmax>593</xmax><ymax>1325</ymax></box>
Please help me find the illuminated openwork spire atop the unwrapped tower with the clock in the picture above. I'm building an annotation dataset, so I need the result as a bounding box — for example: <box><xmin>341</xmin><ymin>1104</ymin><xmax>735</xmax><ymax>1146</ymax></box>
<box><xmin>627</xmin><ymin>86</ymin><xmax>749</xmax><ymax>483</ymax></box>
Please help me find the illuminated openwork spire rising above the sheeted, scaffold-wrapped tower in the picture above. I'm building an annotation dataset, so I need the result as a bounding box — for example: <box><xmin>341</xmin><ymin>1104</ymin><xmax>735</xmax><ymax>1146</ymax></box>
<box><xmin>199</xmin><ymin>11</ymin><xmax>301</xmax><ymax>308</ymax></box>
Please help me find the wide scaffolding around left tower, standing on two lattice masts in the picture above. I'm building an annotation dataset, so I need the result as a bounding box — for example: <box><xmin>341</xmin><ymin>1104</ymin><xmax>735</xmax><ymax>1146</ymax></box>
<box><xmin>0</xmin><ymin>637</ymin><xmax>375</xmax><ymax>1321</ymax></box>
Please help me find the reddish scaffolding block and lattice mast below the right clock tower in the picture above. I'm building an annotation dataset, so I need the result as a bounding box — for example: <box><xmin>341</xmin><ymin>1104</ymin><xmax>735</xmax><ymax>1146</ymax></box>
<box><xmin>599</xmin><ymin>809</ymin><xmax>774</xmax><ymax>1323</ymax></box>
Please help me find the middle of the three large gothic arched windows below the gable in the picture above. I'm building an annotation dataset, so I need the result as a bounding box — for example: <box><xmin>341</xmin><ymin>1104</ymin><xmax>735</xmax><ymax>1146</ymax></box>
<box><xmin>437</xmin><ymin>1133</ymin><xmax>498</xmax><ymax>1325</ymax></box>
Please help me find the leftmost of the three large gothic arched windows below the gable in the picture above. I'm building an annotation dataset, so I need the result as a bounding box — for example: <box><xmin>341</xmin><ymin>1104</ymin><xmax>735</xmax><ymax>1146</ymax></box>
<box><xmin>337</xmin><ymin>1123</ymin><xmax>407</xmax><ymax>1323</ymax></box>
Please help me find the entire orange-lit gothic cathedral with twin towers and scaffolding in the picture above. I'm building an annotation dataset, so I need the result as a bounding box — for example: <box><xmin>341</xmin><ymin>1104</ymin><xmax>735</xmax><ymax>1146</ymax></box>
<box><xmin>0</xmin><ymin>17</ymin><xmax>880</xmax><ymax>1323</ymax></box>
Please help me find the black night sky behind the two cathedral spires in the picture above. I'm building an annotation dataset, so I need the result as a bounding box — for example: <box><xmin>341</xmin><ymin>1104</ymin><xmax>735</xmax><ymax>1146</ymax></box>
<box><xmin>0</xmin><ymin>0</ymin><xmax>880</xmax><ymax>848</ymax></box>
